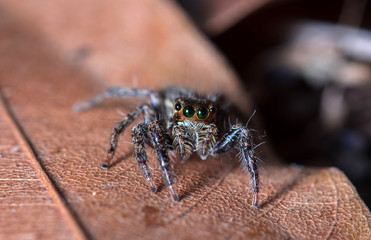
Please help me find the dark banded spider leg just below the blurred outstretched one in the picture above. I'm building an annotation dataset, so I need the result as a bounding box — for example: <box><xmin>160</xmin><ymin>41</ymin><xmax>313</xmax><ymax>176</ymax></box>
<box><xmin>102</xmin><ymin>104</ymin><xmax>150</xmax><ymax>169</ymax></box>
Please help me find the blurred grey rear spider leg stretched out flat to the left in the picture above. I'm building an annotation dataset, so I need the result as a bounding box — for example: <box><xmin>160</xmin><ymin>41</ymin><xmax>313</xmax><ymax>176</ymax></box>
<box><xmin>73</xmin><ymin>87</ymin><xmax>161</xmax><ymax>112</ymax></box>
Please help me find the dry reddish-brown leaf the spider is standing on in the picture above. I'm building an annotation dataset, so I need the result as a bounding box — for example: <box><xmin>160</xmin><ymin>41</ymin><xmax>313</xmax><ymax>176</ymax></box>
<box><xmin>0</xmin><ymin>0</ymin><xmax>371</xmax><ymax>239</ymax></box>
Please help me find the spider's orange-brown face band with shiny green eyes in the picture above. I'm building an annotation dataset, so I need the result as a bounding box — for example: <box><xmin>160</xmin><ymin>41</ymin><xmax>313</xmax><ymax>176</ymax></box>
<box><xmin>174</xmin><ymin>98</ymin><xmax>217</xmax><ymax>124</ymax></box>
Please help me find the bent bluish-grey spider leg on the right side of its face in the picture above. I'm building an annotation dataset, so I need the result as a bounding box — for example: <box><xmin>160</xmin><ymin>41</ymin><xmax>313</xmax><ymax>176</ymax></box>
<box><xmin>213</xmin><ymin>124</ymin><xmax>259</xmax><ymax>209</ymax></box>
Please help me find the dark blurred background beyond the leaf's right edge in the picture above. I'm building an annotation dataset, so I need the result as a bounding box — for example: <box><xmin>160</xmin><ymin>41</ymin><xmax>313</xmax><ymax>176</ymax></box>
<box><xmin>178</xmin><ymin>0</ymin><xmax>371</xmax><ymax>208</ymax></box>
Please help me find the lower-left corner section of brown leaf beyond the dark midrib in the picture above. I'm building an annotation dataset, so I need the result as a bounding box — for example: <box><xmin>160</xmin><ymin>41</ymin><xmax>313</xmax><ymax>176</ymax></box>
<box><xmin>0</xmin><ymin>96</ymin><xmax>78</xmax><ymax>239</ymax></box>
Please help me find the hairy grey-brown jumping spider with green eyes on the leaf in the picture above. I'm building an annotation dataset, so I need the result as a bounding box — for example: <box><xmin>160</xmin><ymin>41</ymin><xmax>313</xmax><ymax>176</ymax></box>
<box><xmin>74</xmin><ymin>87</ymin><xmax>259</xmax><ymax>208</ymax></box>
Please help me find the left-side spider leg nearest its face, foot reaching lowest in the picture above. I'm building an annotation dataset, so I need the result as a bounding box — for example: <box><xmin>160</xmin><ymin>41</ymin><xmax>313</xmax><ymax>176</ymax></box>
<box><xmin>148</xmin><ymin>121</ymin><xmax>179</xmax><ymax>202</ymax></box>
